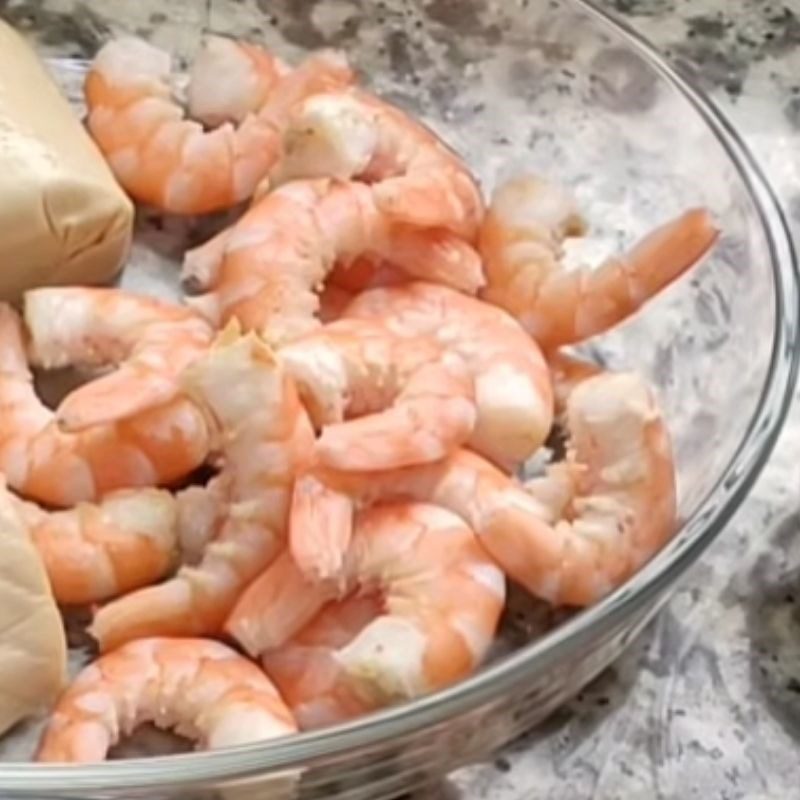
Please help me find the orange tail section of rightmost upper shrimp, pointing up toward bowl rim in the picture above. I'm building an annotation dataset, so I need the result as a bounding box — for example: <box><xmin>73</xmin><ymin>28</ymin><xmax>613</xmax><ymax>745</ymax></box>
<box><xmin>522</xmin><ymin>208</ymin><xmax>719</xmax><ymax>350</ymax></box>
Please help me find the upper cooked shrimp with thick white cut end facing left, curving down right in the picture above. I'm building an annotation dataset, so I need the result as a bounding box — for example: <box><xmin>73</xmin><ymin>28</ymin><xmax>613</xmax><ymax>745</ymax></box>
<box><xmin>268</xmin><ymin>87</ymin><xmax>483</xmax><ymax>241</ymax></box>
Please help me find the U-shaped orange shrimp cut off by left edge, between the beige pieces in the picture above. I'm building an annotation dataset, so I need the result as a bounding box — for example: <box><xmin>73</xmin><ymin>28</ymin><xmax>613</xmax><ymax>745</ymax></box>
<box><xmin>0</xmin><ymin>304</ymin><xmax>210</xmax><ymax>507</ymax></box>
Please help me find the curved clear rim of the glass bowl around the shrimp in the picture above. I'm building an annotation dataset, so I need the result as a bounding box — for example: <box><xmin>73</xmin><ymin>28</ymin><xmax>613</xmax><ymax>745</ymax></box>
<box><xmin>7</xmin><ymin>0</ymin><xmax>800</xmax><ymax>797</ymax></box>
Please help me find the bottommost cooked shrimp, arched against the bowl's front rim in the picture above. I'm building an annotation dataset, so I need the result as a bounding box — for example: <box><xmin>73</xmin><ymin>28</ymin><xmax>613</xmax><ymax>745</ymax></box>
<box><xmin>36</xmin><ymin>639</ymin><xmax>297</xmax><ymax>763</ymax></box>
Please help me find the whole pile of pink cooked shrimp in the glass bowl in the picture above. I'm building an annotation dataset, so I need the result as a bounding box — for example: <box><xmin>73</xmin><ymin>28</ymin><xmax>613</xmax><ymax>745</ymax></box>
<box><xmin>7</xmin><ymin>32</ymin><xmax>718</xmax><ymax>762</ymax></box>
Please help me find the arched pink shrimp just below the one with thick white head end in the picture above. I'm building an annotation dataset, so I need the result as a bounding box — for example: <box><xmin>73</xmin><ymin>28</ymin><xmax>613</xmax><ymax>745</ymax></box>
<box><xmin>185</xmin><ymin>180</ymin><xmax>482</xmax><ymax>345</ymax></box>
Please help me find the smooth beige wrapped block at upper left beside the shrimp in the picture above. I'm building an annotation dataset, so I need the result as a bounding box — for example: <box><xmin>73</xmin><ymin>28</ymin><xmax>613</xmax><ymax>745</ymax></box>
<box><xmin>0</xmin><ymin>20</ymin><xmax>133</xmax><ymax>301</ymax></box>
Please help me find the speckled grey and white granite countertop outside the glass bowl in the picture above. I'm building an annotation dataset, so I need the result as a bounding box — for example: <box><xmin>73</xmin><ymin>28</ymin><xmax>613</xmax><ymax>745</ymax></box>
<box><xmin>0</xmin><ymin>0</ymin><xmax>800</xmax><ymax>800</ymax></box>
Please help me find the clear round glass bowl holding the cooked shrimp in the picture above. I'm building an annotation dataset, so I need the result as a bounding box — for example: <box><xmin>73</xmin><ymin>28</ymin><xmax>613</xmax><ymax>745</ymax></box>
<box><xmin>0</xmin><ymin>0</ymin><xmax>799</xmax><ymax>800</ymax></box>
